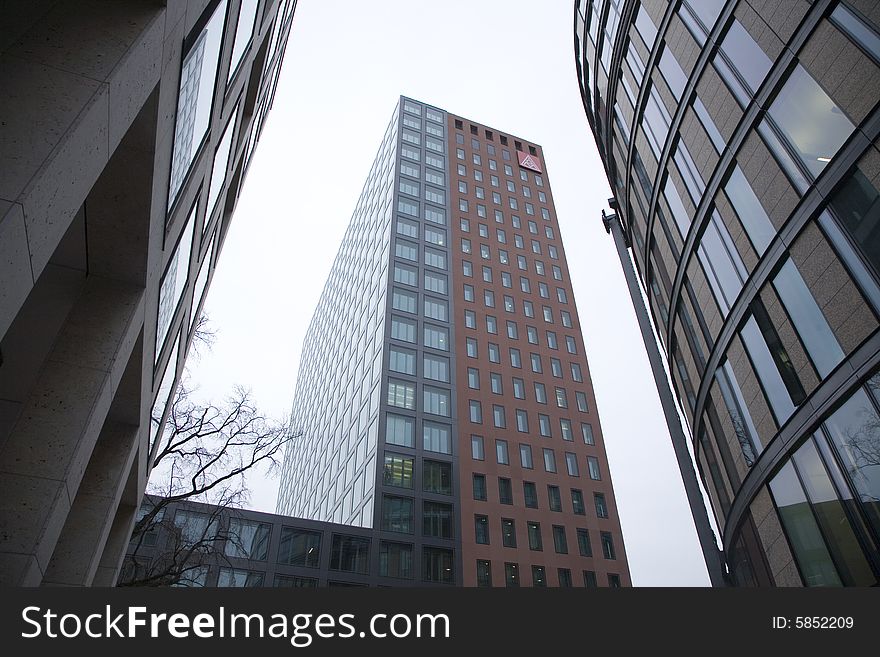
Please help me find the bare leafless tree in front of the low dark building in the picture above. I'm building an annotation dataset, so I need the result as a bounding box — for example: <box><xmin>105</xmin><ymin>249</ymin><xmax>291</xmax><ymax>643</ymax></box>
<box><xmin>120</xmin><ymin>318</ymin><xmax>295</xmax><ymax>586</ymax></box>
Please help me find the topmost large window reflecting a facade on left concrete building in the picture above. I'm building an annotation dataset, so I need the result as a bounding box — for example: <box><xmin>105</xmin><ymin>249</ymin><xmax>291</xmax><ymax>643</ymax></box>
<box><xmin>168</xmin><ymin>0</ymin><xmax>226</xmax><ymax>209</ymax></box>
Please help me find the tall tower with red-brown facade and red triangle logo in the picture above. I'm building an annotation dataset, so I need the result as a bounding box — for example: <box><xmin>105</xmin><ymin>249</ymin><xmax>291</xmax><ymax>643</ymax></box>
<box><xmin>278</xmin><ymin>97</ymin><xmax>630</xmax><ymax>586</ymax></box>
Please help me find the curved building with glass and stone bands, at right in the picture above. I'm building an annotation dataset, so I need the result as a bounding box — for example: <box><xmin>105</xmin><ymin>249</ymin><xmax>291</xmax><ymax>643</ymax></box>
<box><xmin>574</xmin><ymin>0</ymin><xmax>880</xmax><ymax>586</ymax></box>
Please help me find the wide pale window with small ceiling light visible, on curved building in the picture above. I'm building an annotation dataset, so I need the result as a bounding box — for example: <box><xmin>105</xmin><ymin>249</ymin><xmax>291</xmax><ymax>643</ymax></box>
<box><xmin>769</xmin><ymin>65</ymin><xmax>854</xmax><ymax>176</ymax></box>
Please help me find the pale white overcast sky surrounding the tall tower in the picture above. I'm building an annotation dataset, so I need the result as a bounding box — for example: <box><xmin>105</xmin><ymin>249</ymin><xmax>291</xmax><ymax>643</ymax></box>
<box><xmin>182</xmin><ymin>0</ymin><xmax>708</xmax><ymax>586</ymax></box>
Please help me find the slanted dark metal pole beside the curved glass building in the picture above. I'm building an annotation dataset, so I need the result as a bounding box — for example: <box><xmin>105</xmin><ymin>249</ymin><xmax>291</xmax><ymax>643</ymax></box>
<box><xmin>602</xmin><ymin>210</ymin><xmax>727</xmax><ymax>586</ymax></box>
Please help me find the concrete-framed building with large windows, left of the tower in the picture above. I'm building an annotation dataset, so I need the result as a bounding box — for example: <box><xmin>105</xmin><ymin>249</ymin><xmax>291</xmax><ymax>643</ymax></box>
<box><xmin>0</xmin><ymin>0</ymin><xmax>296</xmax><ymax>586</ymax></box>
